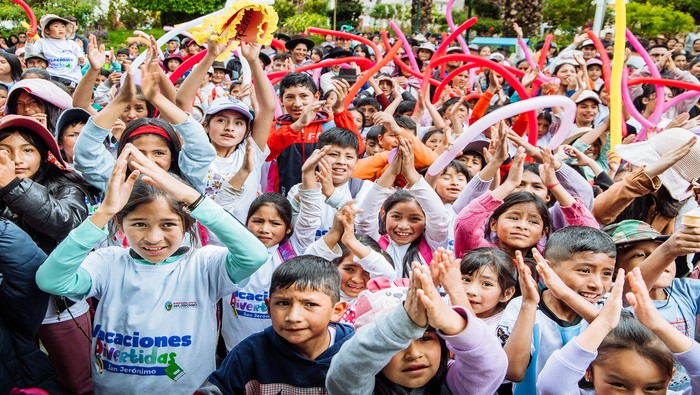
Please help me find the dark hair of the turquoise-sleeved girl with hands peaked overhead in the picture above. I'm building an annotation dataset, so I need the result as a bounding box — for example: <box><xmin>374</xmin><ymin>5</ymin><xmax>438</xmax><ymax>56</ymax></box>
<box><xmin>111</xmin><ymin>179</ymin><xmax>199</xmax><ymax>247</ymax></box>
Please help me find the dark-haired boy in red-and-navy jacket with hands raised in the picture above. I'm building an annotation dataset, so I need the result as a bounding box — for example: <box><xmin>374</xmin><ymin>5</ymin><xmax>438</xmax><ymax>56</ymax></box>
<box><xmin>267</xmin><ymin>72</ymin><xmax>364</xmax><ymax>195</ymax></box>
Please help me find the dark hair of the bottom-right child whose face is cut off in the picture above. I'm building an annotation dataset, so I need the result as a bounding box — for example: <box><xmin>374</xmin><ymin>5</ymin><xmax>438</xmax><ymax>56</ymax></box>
<box><xmin>585</xmin><ymin>310</ymin><xmax>676</xmax><ymax>388</ymax></box>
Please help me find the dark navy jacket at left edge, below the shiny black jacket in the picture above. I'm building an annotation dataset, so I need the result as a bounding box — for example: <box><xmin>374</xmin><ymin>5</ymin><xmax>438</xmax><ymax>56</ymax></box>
<box><xmin>0</xmin><ymin>220</ymin><xmax>59</xmax><ymax>394</ymax></box>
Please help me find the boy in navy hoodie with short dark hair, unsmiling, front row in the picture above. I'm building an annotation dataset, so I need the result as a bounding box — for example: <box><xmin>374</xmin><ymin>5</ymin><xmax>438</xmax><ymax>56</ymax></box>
<box><xmin>196</xmin><ymin>255</ymin><xmax>354</xmax><ymax>395</ymax></box>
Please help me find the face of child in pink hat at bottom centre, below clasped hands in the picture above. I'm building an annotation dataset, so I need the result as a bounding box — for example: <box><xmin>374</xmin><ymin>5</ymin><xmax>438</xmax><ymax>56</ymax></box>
<box><xmin>382</xmin><ymin>331</ymin><xmax>442</xmax><ymax>388</ymax></box>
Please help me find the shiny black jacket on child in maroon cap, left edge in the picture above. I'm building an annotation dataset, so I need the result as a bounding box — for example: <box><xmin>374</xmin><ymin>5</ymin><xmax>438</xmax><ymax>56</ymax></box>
<box><xmin>0</xmin><ymin>178</ymin><xmax>88</xmax><ymax>254</ymax></box>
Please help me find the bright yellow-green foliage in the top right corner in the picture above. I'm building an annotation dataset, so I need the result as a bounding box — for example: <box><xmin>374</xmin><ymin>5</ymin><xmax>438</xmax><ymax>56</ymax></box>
<box><xmin>627</xmin><ymin>3</ymin><xmax>695</xmax><ymax>37</ymax></box>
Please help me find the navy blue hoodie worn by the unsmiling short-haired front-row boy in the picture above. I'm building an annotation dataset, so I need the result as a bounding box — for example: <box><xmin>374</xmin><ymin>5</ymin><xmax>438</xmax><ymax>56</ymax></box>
<box><xmin>197</xmin><ymin>323</ymin><xmax>355</xmax><ymax>394</ymax></box>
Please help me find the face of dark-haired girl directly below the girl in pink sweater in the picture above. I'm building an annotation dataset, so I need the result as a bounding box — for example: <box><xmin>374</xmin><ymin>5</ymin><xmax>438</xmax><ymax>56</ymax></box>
<box><xmin>462</xmin><ymin>266</ymin><xmax>515</xmax><ymax>318</ymax></box>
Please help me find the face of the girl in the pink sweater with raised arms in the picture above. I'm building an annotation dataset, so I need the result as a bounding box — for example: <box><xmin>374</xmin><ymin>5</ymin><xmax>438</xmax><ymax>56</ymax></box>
<box><xmin>490</xmin><ymin>203</ymin><xmax>545</xmax><ymax>250</ymax></box>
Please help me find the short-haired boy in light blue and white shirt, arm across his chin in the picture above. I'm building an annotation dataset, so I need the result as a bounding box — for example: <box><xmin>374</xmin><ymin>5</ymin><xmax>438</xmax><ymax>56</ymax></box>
<box><xmin>498</xmin><ymin>226</ymin><xmax>616</xmax><ymax>394</ymax></box>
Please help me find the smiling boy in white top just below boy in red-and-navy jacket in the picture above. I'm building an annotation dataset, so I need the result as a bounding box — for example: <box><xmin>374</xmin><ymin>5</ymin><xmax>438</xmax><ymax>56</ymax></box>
<box><xmin>287</xmin><ymin>128</ymin><xmax>372</xmax><ymax>239</ymax></box>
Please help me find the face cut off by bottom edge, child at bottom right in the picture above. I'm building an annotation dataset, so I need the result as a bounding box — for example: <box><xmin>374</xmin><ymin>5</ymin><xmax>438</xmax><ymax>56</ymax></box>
<box><xmin>589</xmin><ymin>349</ymin><xmax>671</xmax><ymax>395</ymax></box>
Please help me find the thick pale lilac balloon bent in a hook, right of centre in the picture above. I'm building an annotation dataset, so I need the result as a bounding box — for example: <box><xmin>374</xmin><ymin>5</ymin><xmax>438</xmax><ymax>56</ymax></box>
<box><xmin>428</xmin><ymin>96</ymin><xmax>576</xmax><ymax>176</ymax></box>
